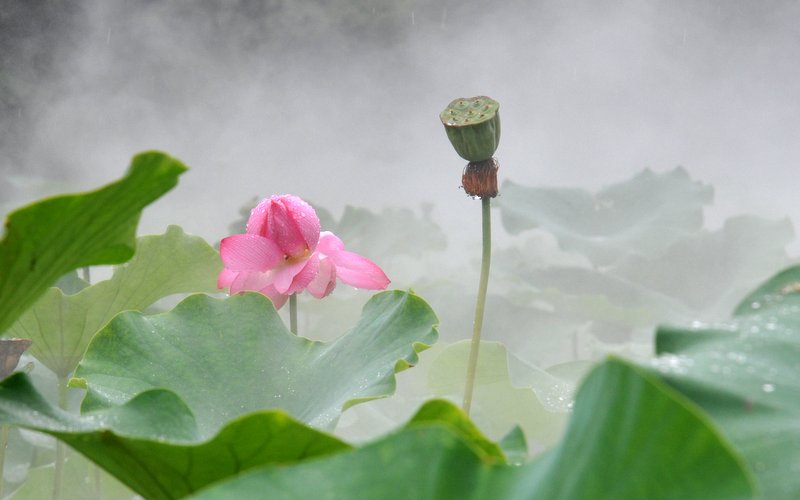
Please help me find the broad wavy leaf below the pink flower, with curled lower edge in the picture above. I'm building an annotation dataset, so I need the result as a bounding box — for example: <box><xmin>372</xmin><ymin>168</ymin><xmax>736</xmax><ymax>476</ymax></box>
<box><xmin>0</xmin><ymin>292</ymin><xmax>438</xmax><ymax>498</ymax></box>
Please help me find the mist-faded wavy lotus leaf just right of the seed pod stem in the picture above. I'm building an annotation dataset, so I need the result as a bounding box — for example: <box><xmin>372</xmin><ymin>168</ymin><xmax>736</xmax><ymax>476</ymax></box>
<box><xmin>497</xmin><ymin>168</ymin><xmax>713</xmax><ymax>266</ymax></box>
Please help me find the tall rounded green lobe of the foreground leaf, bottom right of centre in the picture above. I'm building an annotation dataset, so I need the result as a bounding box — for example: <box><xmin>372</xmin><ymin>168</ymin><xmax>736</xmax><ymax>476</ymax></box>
<box><xmin>528</xmin><ymin>358</ymin><xmax>758</xmax><ymax>499</ymax></box>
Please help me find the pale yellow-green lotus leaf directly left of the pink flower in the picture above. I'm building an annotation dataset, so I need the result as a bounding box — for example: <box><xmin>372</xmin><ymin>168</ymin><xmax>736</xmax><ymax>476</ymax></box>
<box><xmin>9</xmin><ymin>226</ymin><xmax>222</xmax><ymax>378</ymax></box>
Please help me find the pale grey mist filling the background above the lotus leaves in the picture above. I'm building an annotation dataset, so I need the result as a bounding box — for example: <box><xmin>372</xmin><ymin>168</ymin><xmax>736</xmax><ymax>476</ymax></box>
<box><xmin>0</xmin><ymin>0</ymin><xmax>800</xmax><ymax>250</ymax></box>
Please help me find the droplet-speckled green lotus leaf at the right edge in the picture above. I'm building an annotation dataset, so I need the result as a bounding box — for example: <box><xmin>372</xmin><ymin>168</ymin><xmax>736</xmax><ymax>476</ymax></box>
<box><xmin>656</xmin><ymin>267</ymin><xmax>800</xmax><ymax>498</ymax></box>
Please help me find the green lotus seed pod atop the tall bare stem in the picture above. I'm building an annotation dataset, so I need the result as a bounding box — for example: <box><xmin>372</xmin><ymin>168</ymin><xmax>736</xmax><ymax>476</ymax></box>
<box><xmin>439</xmin><ymin>96</ymin><xmax>500</xmax><ymax>161</ymax></box>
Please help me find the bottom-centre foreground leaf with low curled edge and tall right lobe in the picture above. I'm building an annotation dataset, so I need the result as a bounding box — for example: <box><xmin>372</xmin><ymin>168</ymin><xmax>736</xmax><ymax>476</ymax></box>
<box><xmin>192</xmin><ymin>359</ymin><xmax>755</xmax><ymax>500</ymax></box>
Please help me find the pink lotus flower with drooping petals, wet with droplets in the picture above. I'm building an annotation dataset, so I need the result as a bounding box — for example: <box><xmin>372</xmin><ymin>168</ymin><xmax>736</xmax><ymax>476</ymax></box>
<box><xmin>217</xmin><ymin>195</ymin><xmax>389</xmax><ymax>308</ymax></box>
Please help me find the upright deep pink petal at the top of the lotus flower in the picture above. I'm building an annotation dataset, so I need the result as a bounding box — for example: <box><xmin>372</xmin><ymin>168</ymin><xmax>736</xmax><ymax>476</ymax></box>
<box><xmin>265</xmin><ymin>195</ymin><xmax>319</xmax><ymax>257</ymax></box>
